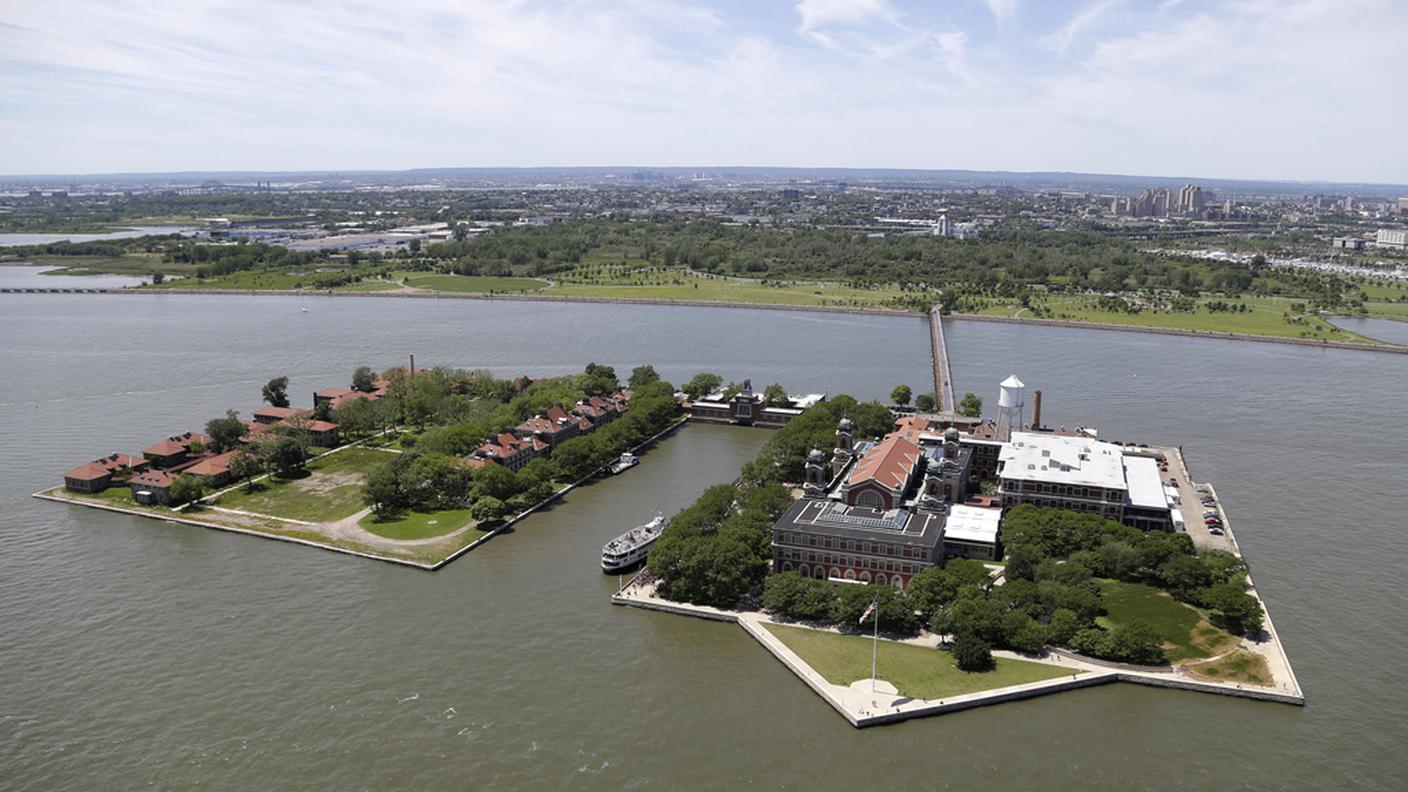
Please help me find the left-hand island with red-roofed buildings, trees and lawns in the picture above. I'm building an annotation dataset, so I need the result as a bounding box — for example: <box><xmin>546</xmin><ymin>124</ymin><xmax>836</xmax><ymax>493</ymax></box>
<box><xmin>35</xmin><ymin>357</ymin><xmax>687</xmax><ymax>569</ymax></box>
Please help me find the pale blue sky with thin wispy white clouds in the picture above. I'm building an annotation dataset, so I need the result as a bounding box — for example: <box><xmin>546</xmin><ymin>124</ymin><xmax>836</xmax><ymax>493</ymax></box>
<box><xmin>0</xmin><ymin>0</ymin><xmax>1408</xmax><ymax>183</ymax></box>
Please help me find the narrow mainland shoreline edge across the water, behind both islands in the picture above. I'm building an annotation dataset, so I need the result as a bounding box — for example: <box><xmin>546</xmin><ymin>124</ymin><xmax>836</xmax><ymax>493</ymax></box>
<box><xmin>0</xmin><ymin>287</ymin><xmax>1408</xmax><ymax>355</ymax></box>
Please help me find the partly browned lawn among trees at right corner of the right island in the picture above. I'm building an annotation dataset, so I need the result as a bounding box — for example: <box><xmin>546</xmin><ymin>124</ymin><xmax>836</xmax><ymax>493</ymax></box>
<box><xmin>1098</xmin><ymin>579</ymin><xmax>1238</xmax><ymax>662</ymax></box>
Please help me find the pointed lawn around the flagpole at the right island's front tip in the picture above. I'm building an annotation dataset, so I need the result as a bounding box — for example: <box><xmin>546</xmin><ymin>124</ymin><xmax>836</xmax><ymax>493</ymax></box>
<box><xmin>763</xmin><ymin>623</ymin><xmax>1069</xmax><ymax>699</ymax></box>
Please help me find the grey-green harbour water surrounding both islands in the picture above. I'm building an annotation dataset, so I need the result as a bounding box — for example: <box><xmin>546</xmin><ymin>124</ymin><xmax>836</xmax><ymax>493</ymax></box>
<box><xmin>0</xmin><ymin>295</ymin><xmax>1408</xmax><ymax>791</ymax></box>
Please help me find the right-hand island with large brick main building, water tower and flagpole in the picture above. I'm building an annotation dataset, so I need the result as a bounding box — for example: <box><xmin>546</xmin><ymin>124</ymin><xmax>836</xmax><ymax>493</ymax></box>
<box><xmin>612</xmin><ymin>376</ymin><xmax>1304</xmax><ymax>726</ymax></box>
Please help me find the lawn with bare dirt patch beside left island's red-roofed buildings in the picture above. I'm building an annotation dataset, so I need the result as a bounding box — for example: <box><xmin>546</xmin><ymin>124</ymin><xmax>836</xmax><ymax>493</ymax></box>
<box><xmin>214</xmin><ymin>448</ymin><xmax>391</xmax><ymax>523</ymax></box>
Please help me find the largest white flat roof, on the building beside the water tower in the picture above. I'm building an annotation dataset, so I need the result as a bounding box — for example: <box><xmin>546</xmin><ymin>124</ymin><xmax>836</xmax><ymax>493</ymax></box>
<box><xmin>998</xmin><ymin>431</ymin><xmax>1126</xmax><ymax>489</ymax></box>
